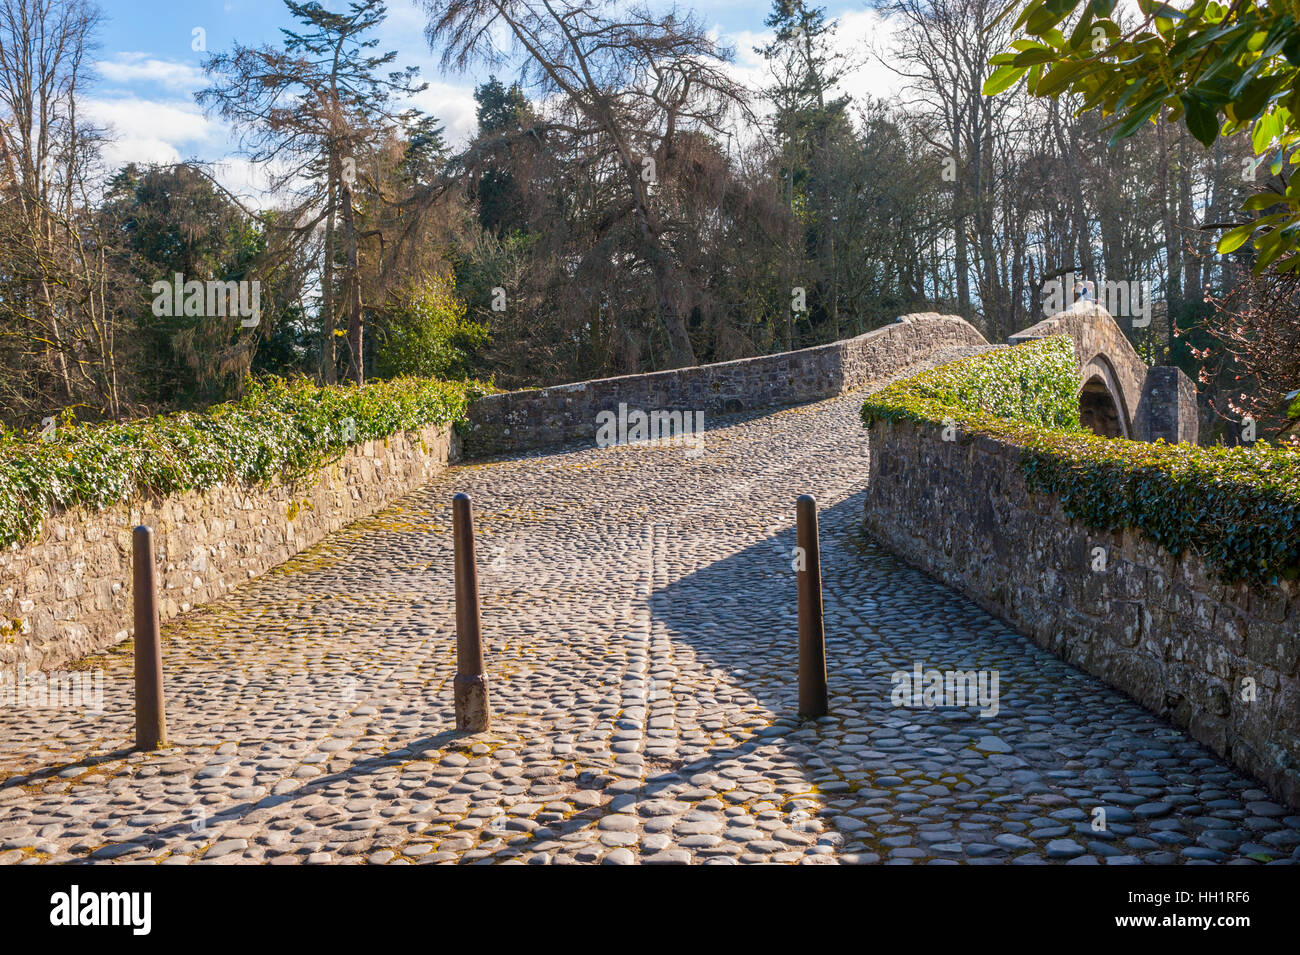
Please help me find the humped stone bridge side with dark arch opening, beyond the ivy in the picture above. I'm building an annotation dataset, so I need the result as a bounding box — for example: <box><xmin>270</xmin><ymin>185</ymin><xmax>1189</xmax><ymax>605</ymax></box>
<box><xmin>1008</xmin><ymin>303</ymin><xmax>1197</xmax><ymax>443</ymax></box>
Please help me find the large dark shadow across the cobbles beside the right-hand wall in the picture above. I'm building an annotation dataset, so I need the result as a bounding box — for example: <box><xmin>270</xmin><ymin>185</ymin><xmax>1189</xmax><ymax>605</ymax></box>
<box><xmin>651</xmin><ymin>485</ymin><xmax>1300</xmax><ymax>863</ymax></box>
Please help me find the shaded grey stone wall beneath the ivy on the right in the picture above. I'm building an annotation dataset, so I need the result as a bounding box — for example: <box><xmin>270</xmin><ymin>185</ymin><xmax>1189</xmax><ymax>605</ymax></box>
<box><xmin>866</xmin><ymin>422</ymin><xmax>1300</xmax><ymax>808</ymax></box>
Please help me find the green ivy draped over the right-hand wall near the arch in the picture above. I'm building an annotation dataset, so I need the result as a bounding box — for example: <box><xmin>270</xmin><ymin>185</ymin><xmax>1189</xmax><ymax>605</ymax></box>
<box><xmin>862</xmin><ymin>337</ymin><xmax>1300</xmax><ymax>583</ymax></box>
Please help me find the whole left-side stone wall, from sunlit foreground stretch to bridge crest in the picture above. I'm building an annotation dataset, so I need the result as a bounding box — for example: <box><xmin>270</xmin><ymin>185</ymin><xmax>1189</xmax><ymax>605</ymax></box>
<box><xmin>0</xmin><ymin>313</ymin><xmax>985</xmax><ymax>674</ymax></box>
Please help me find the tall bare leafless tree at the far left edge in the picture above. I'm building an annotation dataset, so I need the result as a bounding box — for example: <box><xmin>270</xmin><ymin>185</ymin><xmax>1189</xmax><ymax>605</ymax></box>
<box><xmin>0</xmin><ymin>0</ymin><xmax>121</xmax><ymax>414</ymax></box>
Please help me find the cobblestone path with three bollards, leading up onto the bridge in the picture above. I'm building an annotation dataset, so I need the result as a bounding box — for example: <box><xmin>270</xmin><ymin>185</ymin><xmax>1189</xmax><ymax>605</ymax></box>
<box><xmin>0</xmin><ymin>382</ymin><xmax>1300</xmax><ymax>865</ymax></box>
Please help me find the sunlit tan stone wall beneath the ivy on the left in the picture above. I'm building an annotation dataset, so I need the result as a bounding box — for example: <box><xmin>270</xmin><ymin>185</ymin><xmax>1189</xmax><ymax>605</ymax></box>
<box><xmin>0</xmin><ymin>425</ymin><xmax>459</xmax><ymax>673</ymax></box>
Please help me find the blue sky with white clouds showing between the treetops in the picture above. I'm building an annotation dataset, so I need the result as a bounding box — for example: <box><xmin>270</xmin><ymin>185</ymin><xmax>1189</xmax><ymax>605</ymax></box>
<box><xmin>87</xmin><ymin>0</ymin><xmax>892</xmax><ymax>197</ymax></box>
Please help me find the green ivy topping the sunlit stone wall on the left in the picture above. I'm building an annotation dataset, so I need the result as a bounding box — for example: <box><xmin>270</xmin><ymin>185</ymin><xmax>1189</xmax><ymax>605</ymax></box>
<box><xmin>0</xmin><ymin>378</ymin><xmax>481</xmax><ymax>544</ymax></box>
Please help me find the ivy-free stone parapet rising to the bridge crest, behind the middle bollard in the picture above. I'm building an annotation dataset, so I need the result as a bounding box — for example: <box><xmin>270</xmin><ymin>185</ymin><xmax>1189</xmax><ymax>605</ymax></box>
<box><xmin>463</xmin><ymin>312</ymin><xmax>988</xmax><ymax>457</ymax></box>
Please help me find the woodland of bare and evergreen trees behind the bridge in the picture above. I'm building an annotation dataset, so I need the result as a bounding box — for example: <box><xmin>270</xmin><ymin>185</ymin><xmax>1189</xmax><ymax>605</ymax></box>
<box><xmin>0</xmin><ymin>0</ymin><xmax>1300</xmax><ymax>442</ymax></box>
